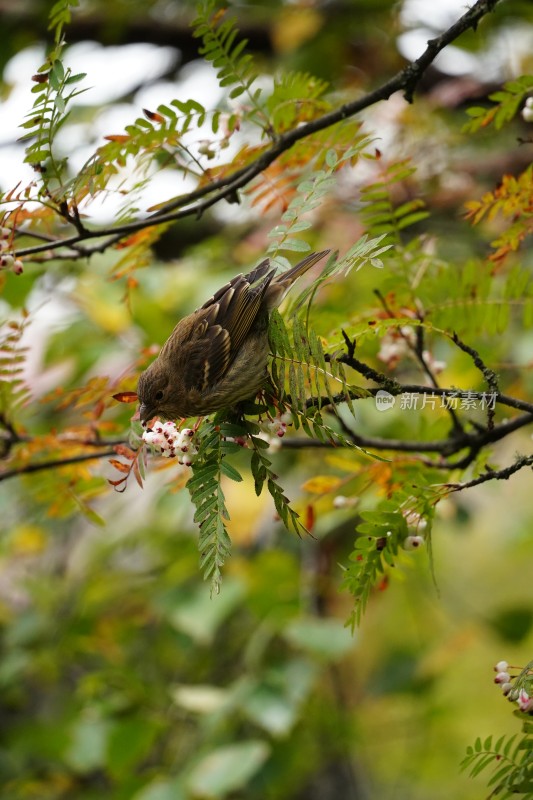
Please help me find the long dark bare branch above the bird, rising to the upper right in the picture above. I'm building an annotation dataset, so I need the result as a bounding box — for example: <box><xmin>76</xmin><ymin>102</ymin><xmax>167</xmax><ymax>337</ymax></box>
<box><xmin>13</xmin><ymin>0</ymin><xmax>500</xmax><ymax>258</ymax></box>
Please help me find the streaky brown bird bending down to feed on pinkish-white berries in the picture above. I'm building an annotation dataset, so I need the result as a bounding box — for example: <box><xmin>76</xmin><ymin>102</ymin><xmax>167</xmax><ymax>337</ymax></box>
<box><xmin>137</xmin><ymin>250</ymin><xmax>329</xmax><ymax>425</ymax></box>
